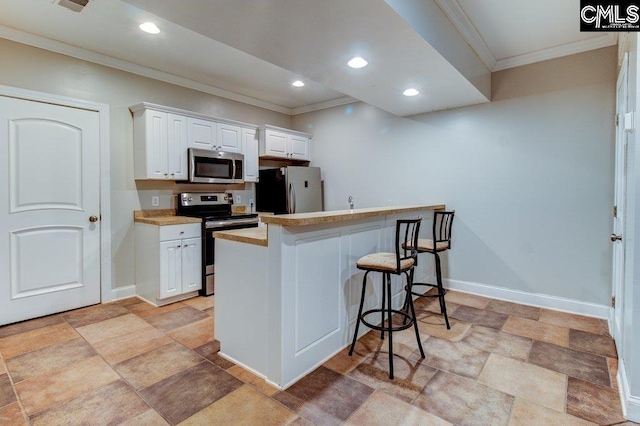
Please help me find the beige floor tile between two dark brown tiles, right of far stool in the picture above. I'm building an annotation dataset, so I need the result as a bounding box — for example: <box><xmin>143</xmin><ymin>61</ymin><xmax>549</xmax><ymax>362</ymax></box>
<box><xmin>464</xmin><ymin>325</ymin><xmax>533</xmax><ymax>361</ymax></box>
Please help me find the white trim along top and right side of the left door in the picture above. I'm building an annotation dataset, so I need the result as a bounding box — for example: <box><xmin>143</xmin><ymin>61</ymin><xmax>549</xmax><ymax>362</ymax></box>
<box><xmin>0</xmin><ymin>85</ymin><xmax>113</xmax><ymax>303</ymax></box>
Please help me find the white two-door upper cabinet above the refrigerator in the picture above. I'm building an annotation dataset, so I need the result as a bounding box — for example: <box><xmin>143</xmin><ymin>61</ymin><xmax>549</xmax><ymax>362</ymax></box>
<box><xmin>260</xmin><ymin>126</ymin><xmax>311</xmax><ymax>161</ymax></box>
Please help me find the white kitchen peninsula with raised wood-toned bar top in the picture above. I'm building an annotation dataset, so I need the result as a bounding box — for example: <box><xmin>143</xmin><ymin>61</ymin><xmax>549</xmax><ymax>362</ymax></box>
<box><xmin>214</xmin><ymin>204</ymin><xmax>445</xmax><ymax>389</ymax></box>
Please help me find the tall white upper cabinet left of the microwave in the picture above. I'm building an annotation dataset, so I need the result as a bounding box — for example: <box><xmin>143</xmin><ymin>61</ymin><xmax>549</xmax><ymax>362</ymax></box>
<box><xmin>133</xmin><ymin>109</ymin><xmax>187</xmax><ymax>180</ymax></box>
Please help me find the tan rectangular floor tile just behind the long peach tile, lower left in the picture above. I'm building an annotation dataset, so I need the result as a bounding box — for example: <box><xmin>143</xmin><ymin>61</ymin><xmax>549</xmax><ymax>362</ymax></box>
<box><xmin>7</xmin><ymin>337</ymin><xmax>97</xmax><ymax>383</ymax></box>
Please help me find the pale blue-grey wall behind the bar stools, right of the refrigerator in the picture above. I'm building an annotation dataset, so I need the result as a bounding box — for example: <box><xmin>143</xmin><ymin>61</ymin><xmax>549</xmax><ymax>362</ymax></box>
<box><xmin>293</xmin><ymin>48</ymin><xmax>616</xmax><ymax>305</ymax></box>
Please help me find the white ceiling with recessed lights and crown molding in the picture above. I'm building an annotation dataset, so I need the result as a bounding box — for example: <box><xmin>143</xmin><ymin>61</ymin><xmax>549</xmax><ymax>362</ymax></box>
<box><xmin>0</xmin><ymin>0</ymin><xmax>616</xmax><ymax>116</ymax></box>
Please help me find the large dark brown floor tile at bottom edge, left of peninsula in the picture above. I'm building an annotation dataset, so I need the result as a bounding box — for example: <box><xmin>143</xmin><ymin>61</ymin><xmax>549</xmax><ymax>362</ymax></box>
<box><xmin>140</xmin><ymin>361</ymin><xmax>242</xmax><ymax>424</ymax></box>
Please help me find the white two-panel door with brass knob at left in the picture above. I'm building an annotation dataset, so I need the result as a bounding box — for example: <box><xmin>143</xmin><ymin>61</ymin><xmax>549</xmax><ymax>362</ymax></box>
<box><xmin>0</xmin><ymin>96</ymin><xmax>100</xmax><ymax>325</ymax></box>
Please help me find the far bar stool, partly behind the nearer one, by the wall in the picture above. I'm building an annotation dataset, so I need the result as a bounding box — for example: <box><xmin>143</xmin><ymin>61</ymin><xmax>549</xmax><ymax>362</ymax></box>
<box><xmin>403</xmin><ymin>211</ymin><xmax>455</xmax><ymax>329</ymax></box>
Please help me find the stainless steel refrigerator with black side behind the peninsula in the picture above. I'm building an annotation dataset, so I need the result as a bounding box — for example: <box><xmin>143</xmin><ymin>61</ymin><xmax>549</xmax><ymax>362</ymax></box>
<box><xmin>256</xmin><ymin>166</ymin><xmax>322</xmax><ymax>214</ymax></box>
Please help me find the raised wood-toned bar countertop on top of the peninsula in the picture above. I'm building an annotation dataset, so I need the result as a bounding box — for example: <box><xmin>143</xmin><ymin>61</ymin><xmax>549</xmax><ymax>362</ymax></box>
<box><xmin>260</xmin><ymin>204</ymin><xmax>445</xmax><ymax>226</ymax></box>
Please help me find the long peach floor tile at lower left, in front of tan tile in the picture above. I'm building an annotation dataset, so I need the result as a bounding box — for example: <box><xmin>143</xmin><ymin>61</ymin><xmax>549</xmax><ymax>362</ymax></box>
<box><xmin>15</xmin><ymin>356</ymin><xmax>120</xmax><ymax>416</ymax></box>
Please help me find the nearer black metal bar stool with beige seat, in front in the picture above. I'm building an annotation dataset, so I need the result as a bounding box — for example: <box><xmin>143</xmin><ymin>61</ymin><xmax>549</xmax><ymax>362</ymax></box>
<box><xmin>349</xmin><ymin>219</ymin><xmax>424</xmax><ymax>379</ymax></box>
